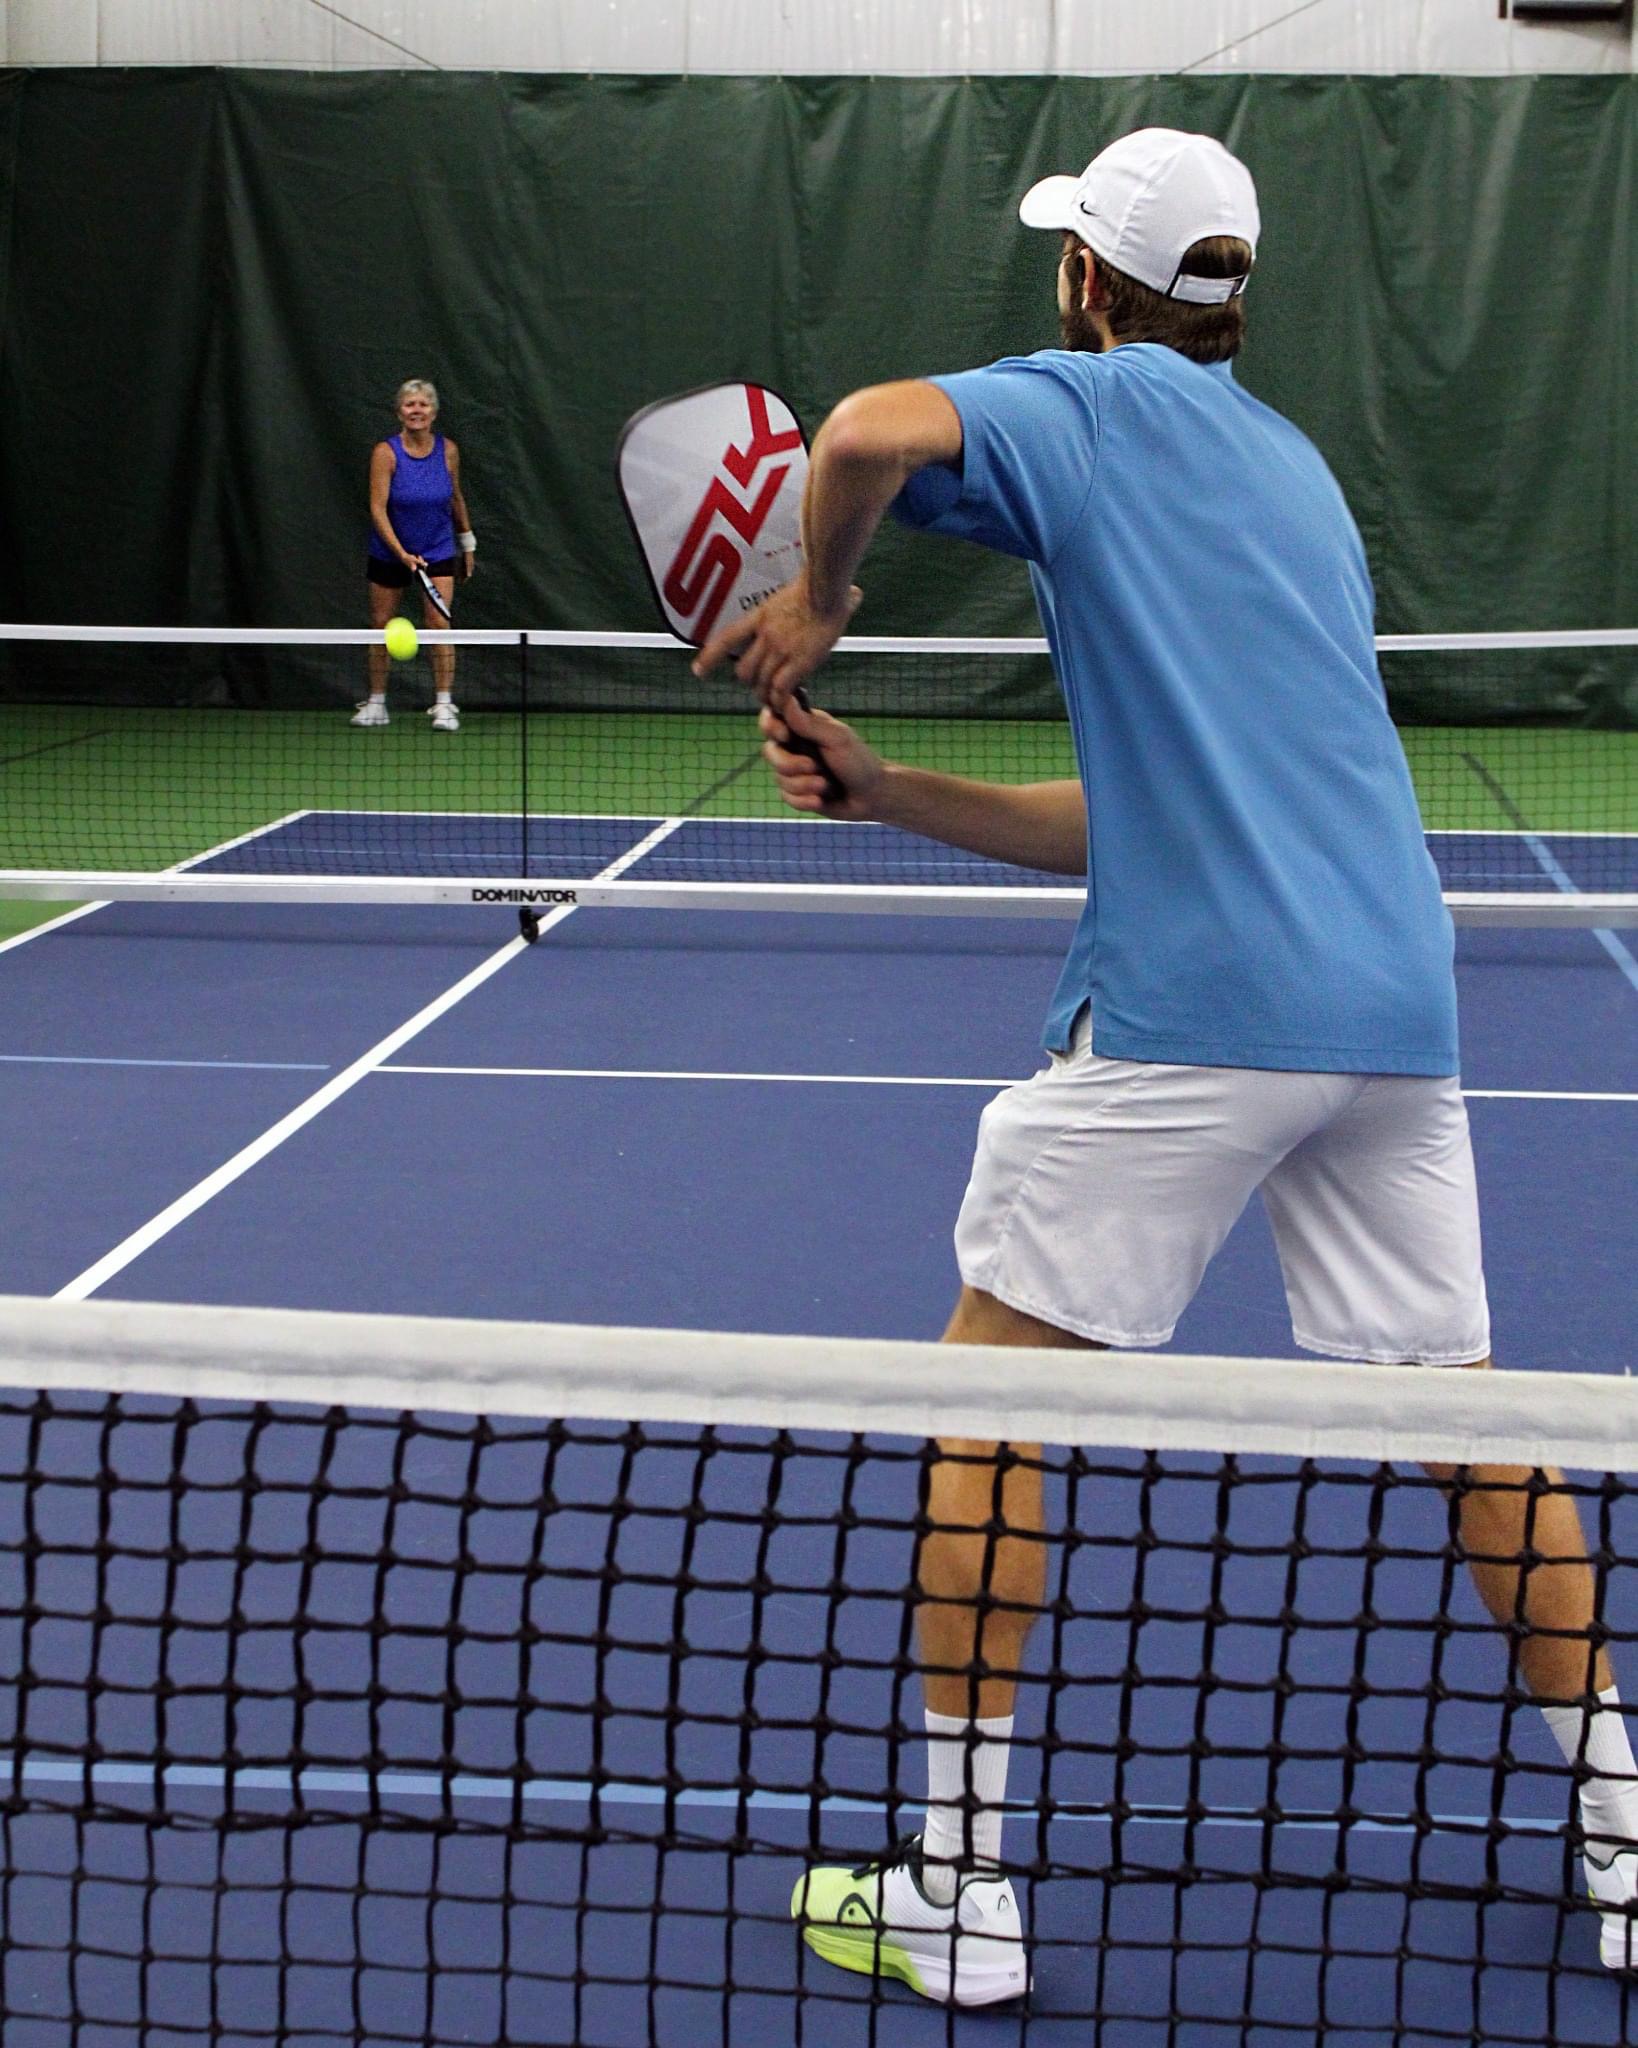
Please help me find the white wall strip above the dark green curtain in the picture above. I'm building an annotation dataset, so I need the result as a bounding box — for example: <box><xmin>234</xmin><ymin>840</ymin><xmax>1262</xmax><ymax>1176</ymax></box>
<box><xmin>0</xmin><ymin>0</ymin><xmax>1638</xmax><ymax>76</ymax></box>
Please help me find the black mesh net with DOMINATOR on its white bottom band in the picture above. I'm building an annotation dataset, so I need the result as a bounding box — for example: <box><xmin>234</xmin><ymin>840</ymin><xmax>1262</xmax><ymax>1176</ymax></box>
<box><xmin>0</xmin><ymin>627</ymin><xmax>1638</xmax><ymax>926</ymax></box>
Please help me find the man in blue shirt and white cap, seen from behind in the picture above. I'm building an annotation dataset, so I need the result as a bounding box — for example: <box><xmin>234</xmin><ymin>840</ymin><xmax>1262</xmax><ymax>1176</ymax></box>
<box><xmin>698</xmin><ymin>129</ymin><xmax>1638</xmax><ymax>2005</ymax></box>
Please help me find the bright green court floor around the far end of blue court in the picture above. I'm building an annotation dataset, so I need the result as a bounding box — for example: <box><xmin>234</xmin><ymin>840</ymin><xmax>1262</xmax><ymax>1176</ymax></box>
<box><xmin>0</xmin><ymin>705</ymin><xmax>1638</xmax><ymax>905</ymax></box>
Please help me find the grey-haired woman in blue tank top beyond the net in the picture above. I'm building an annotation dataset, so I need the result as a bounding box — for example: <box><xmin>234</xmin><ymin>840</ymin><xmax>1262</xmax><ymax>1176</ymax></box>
<box><xmin>352</xmin><ymin>377</ymin><xmax>477</xmax><ymax>733</ymax></box>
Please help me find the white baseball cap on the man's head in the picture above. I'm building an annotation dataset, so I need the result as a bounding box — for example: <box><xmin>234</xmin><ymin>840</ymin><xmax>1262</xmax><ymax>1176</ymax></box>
<box><xmin>1018</xmin><ymin>129</ymin><xmax>1261</xmax><ymax>305</ymax></box>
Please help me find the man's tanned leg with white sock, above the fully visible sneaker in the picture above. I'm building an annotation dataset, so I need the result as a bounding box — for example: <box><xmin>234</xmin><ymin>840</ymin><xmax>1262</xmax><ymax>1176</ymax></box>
<box><xmin>915</xmin><ymin>1288</ymin><xmax>1097</xmax><ymax>1898</ymax></box>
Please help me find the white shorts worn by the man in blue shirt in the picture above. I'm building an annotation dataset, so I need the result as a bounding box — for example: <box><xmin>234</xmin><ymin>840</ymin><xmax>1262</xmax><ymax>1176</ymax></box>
<box><xmin>956</xmin><ymin>1020</ymin><xmax>1491</xmax><ymax>1366</ymax></box>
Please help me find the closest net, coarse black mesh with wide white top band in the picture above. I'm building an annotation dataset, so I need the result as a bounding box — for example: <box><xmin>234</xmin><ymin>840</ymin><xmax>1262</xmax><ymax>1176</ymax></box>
<box><xmin>0</xmin><ymin>1300</ymin><xmax>1638</xmax><ymax>2048</ymax></box>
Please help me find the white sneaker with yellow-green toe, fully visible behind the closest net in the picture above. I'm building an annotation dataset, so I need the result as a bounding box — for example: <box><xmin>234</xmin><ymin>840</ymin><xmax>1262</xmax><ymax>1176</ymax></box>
<box><xmin>790</xmin><ymin>1835</ymin><xmax>1030</xmax><ymax>2005</ymax></box>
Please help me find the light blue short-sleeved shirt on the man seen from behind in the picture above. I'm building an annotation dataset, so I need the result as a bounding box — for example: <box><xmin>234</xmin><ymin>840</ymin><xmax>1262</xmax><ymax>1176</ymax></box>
<box><xmin>895</xmin><ymin>344</ymin><xmax>1458</xmax><ymax>1075</ymax></box>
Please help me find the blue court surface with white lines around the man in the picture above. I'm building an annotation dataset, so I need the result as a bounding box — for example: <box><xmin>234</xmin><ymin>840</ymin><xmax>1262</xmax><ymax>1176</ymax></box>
<box><xmin>0</xmin><ymin>819</ymin><xmax>1638</xmax><ymax>2048</ymax></box>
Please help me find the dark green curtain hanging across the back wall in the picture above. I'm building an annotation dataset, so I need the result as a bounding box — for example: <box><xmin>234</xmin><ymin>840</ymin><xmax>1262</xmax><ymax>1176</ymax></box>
<box><xmin>0</xmin><ymin>70</ymin><xmax>1638</xmax><ymax>633</ymax></box>
